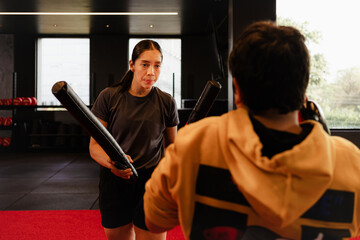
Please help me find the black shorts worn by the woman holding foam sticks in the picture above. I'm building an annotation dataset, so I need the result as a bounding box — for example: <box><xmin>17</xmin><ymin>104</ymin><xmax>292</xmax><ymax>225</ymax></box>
<box><xmin>99</xmin><ymin>167</ymin><xmax>155</xmax><ymax>230</ymax></box>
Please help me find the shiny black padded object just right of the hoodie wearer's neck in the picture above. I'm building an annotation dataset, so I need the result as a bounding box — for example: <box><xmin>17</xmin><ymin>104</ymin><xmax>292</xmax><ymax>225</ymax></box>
<box><xmin>300</xmin><ymin>100</ymin><xmax>331</xmax><ymax>134</ymax></box>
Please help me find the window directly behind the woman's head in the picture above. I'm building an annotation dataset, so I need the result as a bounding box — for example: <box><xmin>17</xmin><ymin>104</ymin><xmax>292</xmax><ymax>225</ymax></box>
<box><xmin>129</xmin><ymin>38</ymin><xmax>181</xmax><ymax>108</ymax></box>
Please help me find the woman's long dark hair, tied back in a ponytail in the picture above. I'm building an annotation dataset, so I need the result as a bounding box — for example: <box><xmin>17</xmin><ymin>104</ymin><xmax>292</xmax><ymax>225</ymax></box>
<box><xmin>112</xmin><ymin>40</ymin><xmax>163</xmax><ymax>92</ymax></box>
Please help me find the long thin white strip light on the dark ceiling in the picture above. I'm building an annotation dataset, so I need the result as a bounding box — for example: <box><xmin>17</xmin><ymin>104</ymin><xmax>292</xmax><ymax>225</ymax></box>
<box><xmin>0</xmin><ymin>12</ymin><xmax>178</xmax><ymax>16</ymax></box>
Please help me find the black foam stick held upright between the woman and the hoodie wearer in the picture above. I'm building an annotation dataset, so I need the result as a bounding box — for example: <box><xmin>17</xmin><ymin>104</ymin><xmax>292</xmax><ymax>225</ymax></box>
<box><xmin>186</xmin><ymin>80</ymin><xmax>221</xmax><ymax>124</ymax></box>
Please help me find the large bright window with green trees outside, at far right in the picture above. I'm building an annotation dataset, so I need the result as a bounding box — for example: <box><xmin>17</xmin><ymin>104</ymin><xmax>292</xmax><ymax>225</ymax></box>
<box><xmin>276</xmin><ymin>0</ymin><xmax>360</xmax><ymax>129</ymax></box>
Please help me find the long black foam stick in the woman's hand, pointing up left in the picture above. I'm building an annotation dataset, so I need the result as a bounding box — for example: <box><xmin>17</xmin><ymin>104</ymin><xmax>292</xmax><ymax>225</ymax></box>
<box><xmin>52</xmin><ymin>81</ymin><xmax>138</xmax><ymax>181</ymax></box>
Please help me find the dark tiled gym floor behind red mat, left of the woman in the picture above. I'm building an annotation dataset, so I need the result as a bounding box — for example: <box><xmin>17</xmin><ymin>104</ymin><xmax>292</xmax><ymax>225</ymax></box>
<box><xmin>0</xmin><ymin>151</ymin><xmax>100</xmax><ymax>210</ymax></box>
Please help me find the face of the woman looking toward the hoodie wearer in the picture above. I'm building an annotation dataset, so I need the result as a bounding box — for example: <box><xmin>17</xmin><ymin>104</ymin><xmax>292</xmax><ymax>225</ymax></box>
<box><xmin>129</xmin><ymin>50</ymin><xmax>161</xmax><ymax>90</ymax></box>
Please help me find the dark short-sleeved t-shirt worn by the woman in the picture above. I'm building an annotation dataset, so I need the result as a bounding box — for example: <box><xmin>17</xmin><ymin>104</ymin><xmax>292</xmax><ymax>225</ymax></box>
<box><xmin>91</xmin><ymin>87</ymin><xmax>179</xmax><ymax>169</ymax></box>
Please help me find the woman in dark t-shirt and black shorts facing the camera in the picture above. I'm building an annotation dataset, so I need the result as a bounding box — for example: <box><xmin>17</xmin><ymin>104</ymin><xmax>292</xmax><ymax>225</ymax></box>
<box><xmin>89</xmin><ymin>40</ymin><xmax>179</xmax><ymax>240</ymax></box>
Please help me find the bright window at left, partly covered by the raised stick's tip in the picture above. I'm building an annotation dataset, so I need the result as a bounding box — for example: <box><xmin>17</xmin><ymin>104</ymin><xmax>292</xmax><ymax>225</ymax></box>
<box><xmin>37</xmin><ymin>38</ymin><xmax>90</xmax><ymax>106</ymax></box>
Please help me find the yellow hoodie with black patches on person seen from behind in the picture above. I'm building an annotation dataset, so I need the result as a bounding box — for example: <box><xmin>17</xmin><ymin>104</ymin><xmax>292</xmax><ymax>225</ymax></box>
<box><xmin>144</xmin><ymin>109</ymin><xmax>360</xmax><ymax>239</ymax></box>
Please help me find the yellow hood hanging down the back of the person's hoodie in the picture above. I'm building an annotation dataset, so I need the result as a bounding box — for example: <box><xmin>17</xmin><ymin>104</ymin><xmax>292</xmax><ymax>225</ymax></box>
<box><xmin>220</xmin><ymin>108</ymin><xmax>335</xmax><ymax>228</ymax></box>
